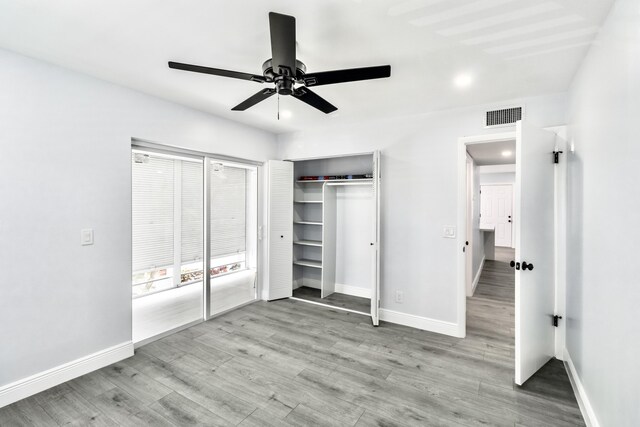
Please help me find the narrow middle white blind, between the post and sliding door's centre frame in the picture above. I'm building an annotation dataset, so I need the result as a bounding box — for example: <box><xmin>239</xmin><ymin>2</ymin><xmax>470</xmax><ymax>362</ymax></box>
<box><xmin>180</xmin><ymin>161</ymin><xmax>203</xmax><ymax>263</ymax></box>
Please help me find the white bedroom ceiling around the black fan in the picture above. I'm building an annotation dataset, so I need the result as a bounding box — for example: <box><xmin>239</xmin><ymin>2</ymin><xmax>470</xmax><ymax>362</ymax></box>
<box><xmin>0</xmin><ymin>0</ymin><xmax>613</xmax><ymax>133</ymax></box>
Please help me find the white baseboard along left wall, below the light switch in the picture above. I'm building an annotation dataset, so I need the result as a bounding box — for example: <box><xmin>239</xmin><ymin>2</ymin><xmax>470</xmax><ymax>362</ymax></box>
<box><xmin>0</xmin><ymin>342</ymin><xmax>133</xmax><ymax>408</ymax></box>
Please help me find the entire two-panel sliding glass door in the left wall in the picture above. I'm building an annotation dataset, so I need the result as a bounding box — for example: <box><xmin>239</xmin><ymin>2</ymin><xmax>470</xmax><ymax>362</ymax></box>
<box><xmin>131</xmin><ymin>148</ymin><xmax>257</xmax><ymax>342</ymax></box>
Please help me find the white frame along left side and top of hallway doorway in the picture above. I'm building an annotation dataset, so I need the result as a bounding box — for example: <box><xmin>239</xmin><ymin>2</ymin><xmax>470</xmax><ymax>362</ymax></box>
<box><xmin>456</xmin><ymin>130</ymin><xmax>516</xmax><ymax>338</ymax></box>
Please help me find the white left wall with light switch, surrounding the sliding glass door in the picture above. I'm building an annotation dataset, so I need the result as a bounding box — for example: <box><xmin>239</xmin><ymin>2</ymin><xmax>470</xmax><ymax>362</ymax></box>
<box><xmin>0</xmin><ymin>51</ymin><xmax>276</xmax><ymax>386</ymax></box>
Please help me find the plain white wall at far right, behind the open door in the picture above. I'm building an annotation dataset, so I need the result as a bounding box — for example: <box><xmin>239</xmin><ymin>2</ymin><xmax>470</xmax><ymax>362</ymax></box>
<box><xmin>565</xmin><ymin>0</ymin><xmax>640</xmax><ymax>426</ymax></box>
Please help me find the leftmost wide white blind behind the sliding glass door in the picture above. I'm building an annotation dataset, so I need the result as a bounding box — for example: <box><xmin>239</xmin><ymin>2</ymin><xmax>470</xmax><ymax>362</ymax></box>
<box><xmin>131</xmin><ymin>153</ymin><xmax>174</xmax><ymax>271</ymax></box>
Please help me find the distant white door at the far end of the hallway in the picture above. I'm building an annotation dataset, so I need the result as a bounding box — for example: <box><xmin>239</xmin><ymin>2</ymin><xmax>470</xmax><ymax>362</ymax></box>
<box><xmin>480</xmin><ymin>185</ymin><xmax>513</xmax><ymax>248</ymax></box>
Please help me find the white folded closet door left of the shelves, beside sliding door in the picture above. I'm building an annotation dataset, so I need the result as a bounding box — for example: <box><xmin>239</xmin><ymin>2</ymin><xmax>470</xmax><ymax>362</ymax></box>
<box><xmin>265</xmin><ymin>160</ymin><xmax>293</xmax><ymax>301</ymax></box>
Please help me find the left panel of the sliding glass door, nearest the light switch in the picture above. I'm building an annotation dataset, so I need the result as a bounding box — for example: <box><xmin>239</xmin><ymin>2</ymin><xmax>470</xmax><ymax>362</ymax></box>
<box><xmin>131</xmin><ymin>150</ymin><xmax>204</xmax><ymax>342</ymax></box>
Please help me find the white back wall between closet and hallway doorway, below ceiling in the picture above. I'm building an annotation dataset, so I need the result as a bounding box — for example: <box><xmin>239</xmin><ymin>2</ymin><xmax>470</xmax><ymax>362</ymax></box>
<box><xmin>278</xmin><ymin>94</ymin><xmax>566</xmax><ymax>323</ymax></box>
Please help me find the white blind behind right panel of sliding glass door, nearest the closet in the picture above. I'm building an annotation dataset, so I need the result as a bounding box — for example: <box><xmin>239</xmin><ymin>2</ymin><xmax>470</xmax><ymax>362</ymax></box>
<box><xmin>209</xmin><ymin>163</ymin><xmax>247</xmax><ymax>258</ymax></box>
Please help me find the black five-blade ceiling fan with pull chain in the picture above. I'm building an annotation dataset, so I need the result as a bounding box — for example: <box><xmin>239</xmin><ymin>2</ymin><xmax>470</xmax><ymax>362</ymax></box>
<box><xmin>169</xmin><ymin>12</ymin><xmax>391</xmax><ymax>114</ymax></box>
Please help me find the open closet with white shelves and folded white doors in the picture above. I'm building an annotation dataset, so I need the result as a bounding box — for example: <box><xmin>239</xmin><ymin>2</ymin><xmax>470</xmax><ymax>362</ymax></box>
<box><xmin>264</xmin><ymin>152</ymin><xmax>380</xmax><ymax>325</ymax></box>
